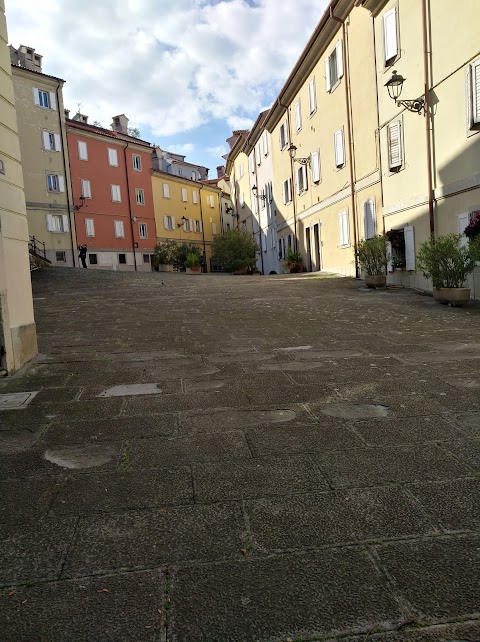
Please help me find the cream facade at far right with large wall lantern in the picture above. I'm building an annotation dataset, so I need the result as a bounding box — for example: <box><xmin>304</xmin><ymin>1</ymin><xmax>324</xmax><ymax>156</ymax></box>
<box><xmin>363</xmin><ymin>0</ymin><xmax>480</xmax><ymax>298</ymax></box>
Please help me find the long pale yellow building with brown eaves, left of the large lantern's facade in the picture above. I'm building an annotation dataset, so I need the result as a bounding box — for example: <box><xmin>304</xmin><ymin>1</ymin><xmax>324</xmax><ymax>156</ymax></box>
<box><xmin>265</xmin><ymin>0</ymin><xmax>383</xmax><ymax>275</ymax></box>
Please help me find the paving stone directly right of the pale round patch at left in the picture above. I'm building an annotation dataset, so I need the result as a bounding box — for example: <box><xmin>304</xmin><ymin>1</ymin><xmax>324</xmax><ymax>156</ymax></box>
<box><xmin>128</xmin><ymin>431</ymin><xmax>252</xmax><ymax>469</ymax></box>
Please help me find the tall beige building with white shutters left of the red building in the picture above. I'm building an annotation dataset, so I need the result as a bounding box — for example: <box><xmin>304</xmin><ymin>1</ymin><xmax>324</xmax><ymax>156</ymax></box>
<box><xmin>10</xmin><ymin>45</ymin><xmax>77</xmax><ymax>266</ymax></box>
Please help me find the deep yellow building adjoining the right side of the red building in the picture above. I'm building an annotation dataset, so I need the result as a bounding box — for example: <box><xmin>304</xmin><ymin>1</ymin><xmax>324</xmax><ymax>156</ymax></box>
<box><xmin>152</xmin><ymin>170</ymin><xmax>222</xmax><ymax>272</ymax></box>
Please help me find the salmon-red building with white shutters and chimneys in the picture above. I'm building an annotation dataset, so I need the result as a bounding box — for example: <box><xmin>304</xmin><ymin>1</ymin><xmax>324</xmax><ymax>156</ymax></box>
<box><xmin>66</xmin><ymin>114</ymin><xmax>156</xmax><ymax>271</ymax></box>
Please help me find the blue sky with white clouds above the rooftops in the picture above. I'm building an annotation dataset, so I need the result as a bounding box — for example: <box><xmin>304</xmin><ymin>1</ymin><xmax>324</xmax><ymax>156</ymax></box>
<box><xmin>6</xmin><ymin>0</ymin><xmax>328</xmax><ymax>172</ymax></box>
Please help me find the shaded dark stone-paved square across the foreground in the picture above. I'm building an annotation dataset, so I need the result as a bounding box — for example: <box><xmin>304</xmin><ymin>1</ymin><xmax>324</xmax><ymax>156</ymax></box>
<box><xmin>0</xmin><ymin>269</ymin><xmax>480</xmax><ymax>642</ymax></box>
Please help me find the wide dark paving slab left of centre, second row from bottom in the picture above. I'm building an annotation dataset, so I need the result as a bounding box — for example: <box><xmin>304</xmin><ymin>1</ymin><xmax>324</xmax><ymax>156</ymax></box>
<box><xmin>64</xmin><ymin>504</ymin><xmax>244</xmax><ymax>577</ymax></box>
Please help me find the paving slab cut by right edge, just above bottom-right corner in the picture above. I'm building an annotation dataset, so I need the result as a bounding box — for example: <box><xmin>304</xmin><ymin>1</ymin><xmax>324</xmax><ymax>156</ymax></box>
<box><xmin>377</xmin><ymin>536</ymin><xmax>480</xmax><ymax>621</ymax></box>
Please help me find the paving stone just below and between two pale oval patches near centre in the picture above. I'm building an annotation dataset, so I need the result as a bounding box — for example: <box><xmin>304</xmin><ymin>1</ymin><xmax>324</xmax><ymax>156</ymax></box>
<box><xmin>247</xmin><ymin>417</ymin><xmax>363</xmax><ymax>456</ymax></box>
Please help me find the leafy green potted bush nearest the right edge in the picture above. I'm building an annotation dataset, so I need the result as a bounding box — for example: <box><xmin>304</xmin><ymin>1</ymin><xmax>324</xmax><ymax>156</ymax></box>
<box><xmin>417</xmin><ymin>234</ymin><xmax>480</xmax><ymax>306</ymax></box>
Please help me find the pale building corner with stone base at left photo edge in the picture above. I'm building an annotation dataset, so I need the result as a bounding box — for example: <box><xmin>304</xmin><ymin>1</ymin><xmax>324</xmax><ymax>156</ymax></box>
<box><xmin>0</xmin><ymin>7</ymin><xmax>37</xmax><ymax>374</ymax></box>
